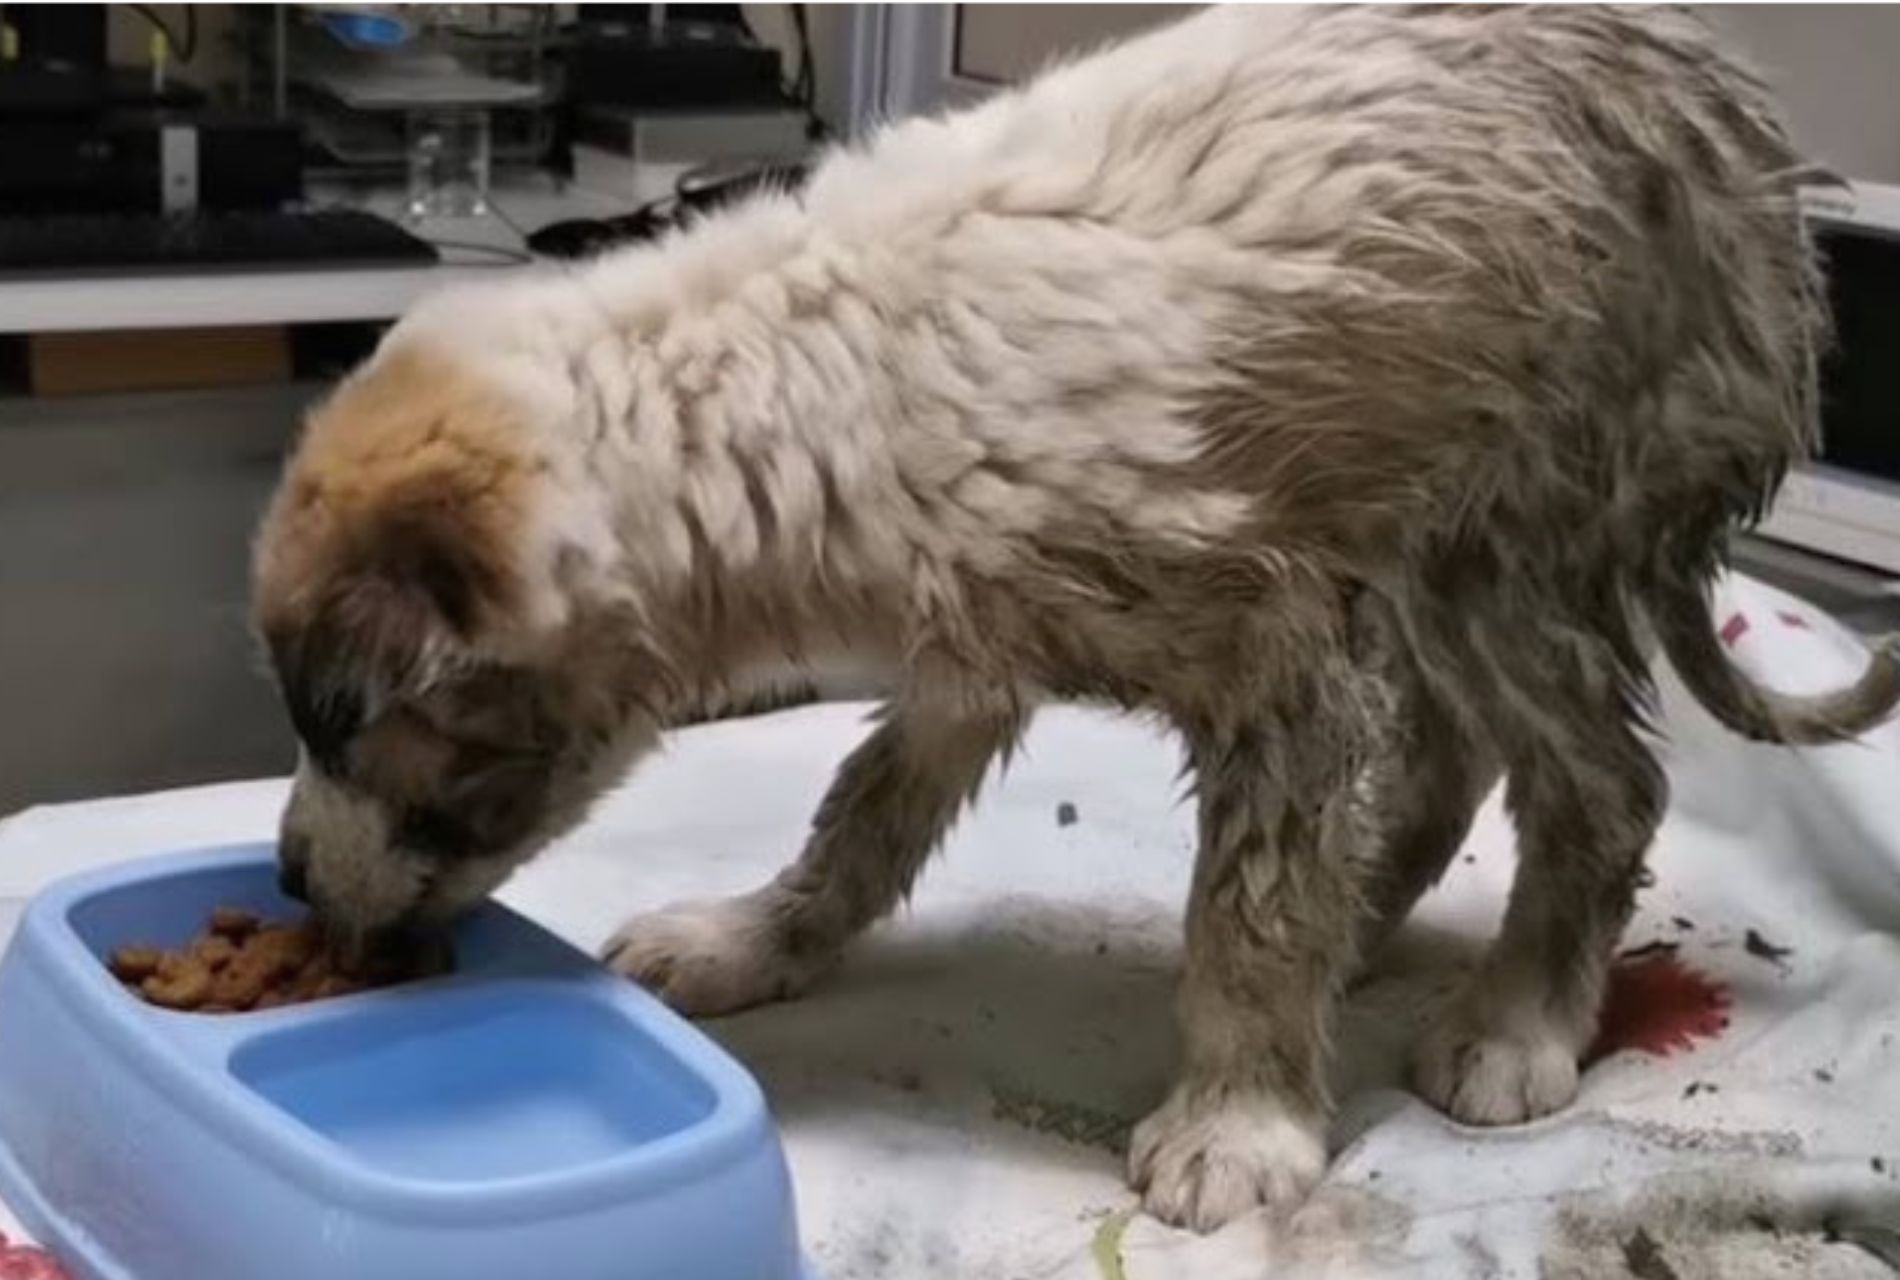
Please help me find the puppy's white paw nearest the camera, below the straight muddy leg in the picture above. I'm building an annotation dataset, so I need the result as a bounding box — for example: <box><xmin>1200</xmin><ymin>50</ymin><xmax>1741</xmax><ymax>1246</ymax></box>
<box><xmin>1129</xmin><ymin>1084</ymin><xmax>1326</xmax><ymax>1233</ymax></box>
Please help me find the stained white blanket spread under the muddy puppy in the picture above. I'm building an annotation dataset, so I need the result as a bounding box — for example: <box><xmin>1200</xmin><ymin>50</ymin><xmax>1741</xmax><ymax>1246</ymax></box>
<box><xmin>0</xmin><ymin>581</ymin><xmax>1900</xmax><ymax>1280</ymax></box>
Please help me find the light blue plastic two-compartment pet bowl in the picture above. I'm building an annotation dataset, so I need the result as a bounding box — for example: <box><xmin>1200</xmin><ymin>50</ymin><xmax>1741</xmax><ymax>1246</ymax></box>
<box><xmin>0</xmin><ymin>845</ymin><xmax>809</xmax><ymax>1280</ymax></box>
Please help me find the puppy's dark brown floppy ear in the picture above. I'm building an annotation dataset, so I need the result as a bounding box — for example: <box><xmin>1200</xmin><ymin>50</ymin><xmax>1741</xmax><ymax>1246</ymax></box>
<box><xmin>260</xmin><ymin>477</ymin><xmax>515</xmax><ymax>760</ymax></box>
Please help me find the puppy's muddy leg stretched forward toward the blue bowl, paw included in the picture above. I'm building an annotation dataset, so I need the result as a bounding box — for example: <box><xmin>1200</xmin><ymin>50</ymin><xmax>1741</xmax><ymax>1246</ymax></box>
<box><xmin>604</xmin><ymin>701</ymin><xmax>1024</xmax><ymax>1016</ymax></box>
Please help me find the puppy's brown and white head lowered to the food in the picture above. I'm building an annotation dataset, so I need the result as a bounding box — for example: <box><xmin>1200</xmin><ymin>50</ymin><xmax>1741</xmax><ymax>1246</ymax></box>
<box><xmin>253</xmin><ymin>353</ymin><xmax>657</xmax><ymax>953</ymax></box>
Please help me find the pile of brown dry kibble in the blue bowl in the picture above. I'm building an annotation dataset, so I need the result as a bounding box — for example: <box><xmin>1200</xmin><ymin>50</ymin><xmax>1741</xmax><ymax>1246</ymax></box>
<box><xmin>106</xmin><ymin>908</ymin><xmax>448</xmax><ymax>1014</ymax></box>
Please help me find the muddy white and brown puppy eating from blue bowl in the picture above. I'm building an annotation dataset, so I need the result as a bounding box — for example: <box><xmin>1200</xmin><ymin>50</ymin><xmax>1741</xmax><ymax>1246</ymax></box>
<box><xmin>255</xmin><ymin>8</ymin><xmax>1900</xmax><ymax>1229</ymax></box>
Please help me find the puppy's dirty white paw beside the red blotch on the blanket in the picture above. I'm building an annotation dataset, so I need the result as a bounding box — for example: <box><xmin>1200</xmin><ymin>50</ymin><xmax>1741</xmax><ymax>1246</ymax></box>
<box><xmin>1414</xmin><ymin>1001</ymin><xmax>1577</xmax><ymax>1124</ymax></box>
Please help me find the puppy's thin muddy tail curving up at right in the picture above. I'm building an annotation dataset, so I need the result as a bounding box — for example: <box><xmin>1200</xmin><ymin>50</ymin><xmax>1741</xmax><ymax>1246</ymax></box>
<box><xmin>1644</xmin><ymin>579</ymin><xmax>1900</xmax><ymax>746</ymax></box>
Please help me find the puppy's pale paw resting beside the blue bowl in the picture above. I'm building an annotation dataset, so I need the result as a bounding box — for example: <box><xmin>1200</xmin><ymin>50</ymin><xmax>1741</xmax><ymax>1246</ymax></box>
<box><xmin>600</xmin><ymin>891</ymin><xmax>828</xmax><ymax>1018</ymax></box>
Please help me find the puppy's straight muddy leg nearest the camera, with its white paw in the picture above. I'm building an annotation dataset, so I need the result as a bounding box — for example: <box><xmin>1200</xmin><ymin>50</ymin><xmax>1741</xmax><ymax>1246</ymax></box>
<box><xmin>1129</xmin><ymin>706</ymin><xmax>1364</xmax><ymax>1231</ymax></box>
